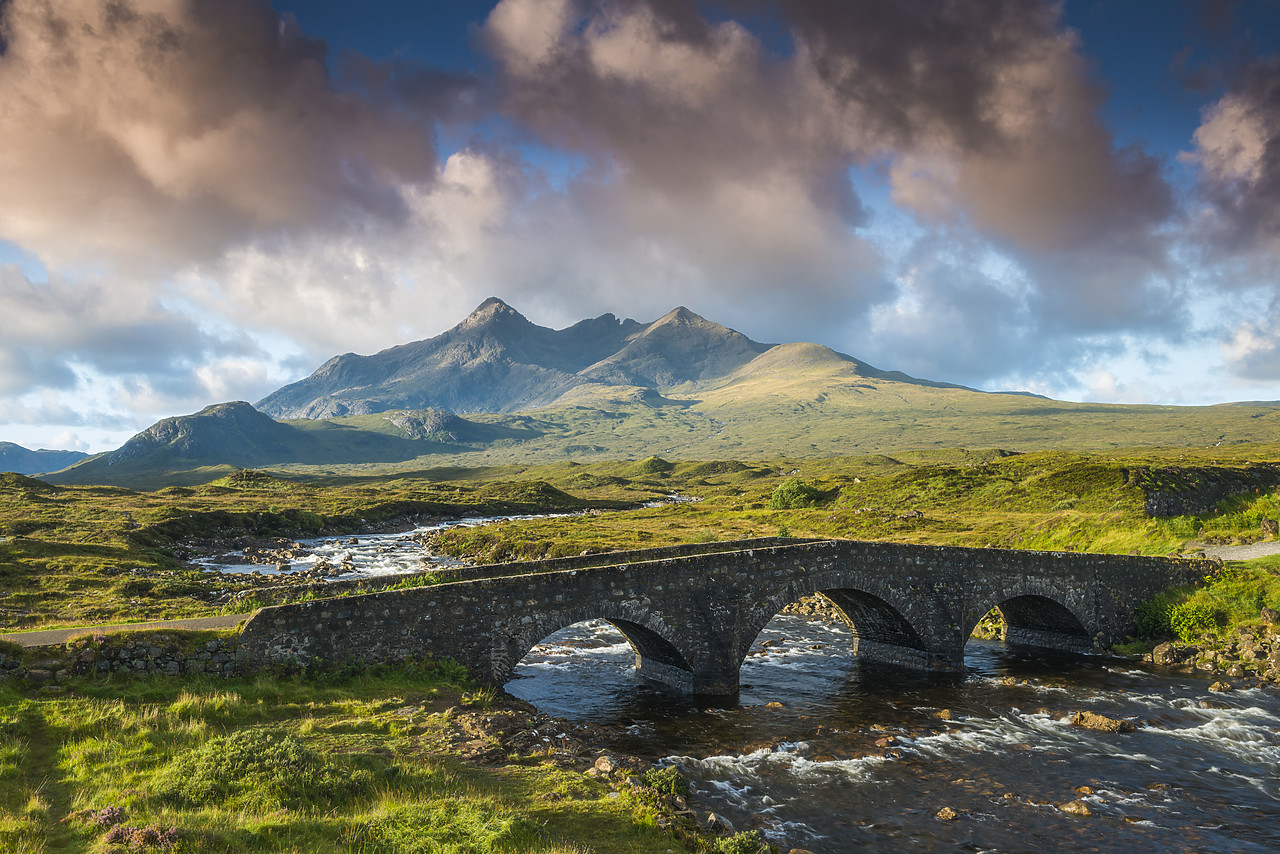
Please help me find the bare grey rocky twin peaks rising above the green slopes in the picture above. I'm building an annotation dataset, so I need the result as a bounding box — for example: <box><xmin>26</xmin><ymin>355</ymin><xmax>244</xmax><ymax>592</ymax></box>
<box><xmin>257</xmin><ymin>298</ymin><xmax>768</xmax><ymax>419</ymax></box>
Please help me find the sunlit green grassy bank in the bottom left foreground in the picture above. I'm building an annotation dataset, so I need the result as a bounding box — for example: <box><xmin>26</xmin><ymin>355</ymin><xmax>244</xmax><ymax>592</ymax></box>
<box><xmin>0</xmin><ymin>667</ymin><xmax>682</xmax><ymax>854</ymax></box>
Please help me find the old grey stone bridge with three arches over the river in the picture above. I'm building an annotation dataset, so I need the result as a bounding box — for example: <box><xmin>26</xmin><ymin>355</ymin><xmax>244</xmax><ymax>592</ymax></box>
<box><xmin>241</xmin><ymin>538</ymin><xmax>1211</xmax><ymax>695</ymax></box>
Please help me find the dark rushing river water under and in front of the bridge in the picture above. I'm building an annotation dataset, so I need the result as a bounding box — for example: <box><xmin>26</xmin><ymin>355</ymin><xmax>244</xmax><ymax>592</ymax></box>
<box><xmin>507</xmin><ymin>617</ymin><xmax>1280</xmax><ymax>854</ymax></box>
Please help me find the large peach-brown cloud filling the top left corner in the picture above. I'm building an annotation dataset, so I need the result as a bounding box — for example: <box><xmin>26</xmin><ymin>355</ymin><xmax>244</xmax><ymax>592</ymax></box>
<box><xmin>0</xmin><ymin>0</ymin><xmax>465</xmax><ymax>270</ymax></box>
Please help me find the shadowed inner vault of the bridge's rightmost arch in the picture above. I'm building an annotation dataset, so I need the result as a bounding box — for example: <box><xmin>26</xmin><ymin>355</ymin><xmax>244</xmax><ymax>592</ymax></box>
<box><xmin>964</xmin><ymin>581</ymin><xmax>1096</xmax><ymax>652</ymax></box>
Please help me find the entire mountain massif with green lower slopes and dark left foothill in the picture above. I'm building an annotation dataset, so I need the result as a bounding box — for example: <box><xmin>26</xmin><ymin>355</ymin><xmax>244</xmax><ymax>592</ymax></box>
<box><xmin>44</xmin><ymin>300</ymin><xmax>1280</xmax><ymax>488</ymax></box>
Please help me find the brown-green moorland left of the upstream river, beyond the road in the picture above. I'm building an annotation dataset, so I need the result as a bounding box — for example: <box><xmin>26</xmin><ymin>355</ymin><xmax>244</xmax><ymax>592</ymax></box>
<box><xmin>0</xmin><ymin>471</ymin><xmax>617</xmax><ymax>629</ymax></box>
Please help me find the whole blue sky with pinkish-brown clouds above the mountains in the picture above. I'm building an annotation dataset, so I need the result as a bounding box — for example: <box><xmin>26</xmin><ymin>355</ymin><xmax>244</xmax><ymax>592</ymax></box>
<box><xmin>0</xmin><ymin>0</ymin><xmax>1280</xmax><ymax>452</ymax></box>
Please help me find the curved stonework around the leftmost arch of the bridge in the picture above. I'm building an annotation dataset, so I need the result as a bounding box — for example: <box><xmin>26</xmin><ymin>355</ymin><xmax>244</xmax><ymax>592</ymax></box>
<box><xmin>492</xmin><ymin>603</ymin><xmax>694</xmax><ymax>690</ymax></box>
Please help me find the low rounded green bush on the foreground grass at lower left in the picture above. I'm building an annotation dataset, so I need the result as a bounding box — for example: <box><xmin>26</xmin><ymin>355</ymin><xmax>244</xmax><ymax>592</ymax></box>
<box><xmin>152</xmin><ymin>730</ymin><xmax>376</xmax><ymax>809</ymax></box>
